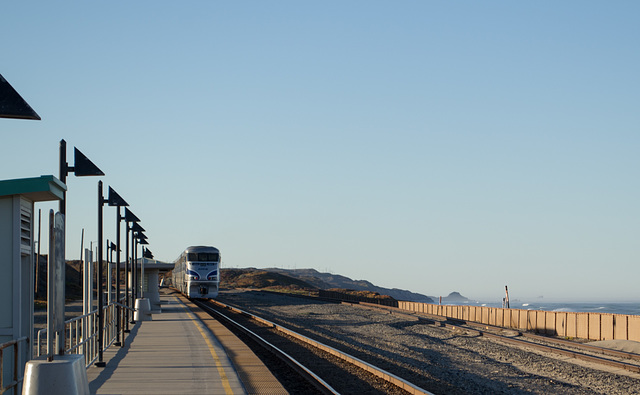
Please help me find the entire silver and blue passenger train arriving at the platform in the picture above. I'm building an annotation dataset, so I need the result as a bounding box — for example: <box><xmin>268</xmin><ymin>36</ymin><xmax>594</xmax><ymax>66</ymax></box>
<box><xmin>172</xmin><ymin>246</ymin><xmax>221</xmax><ymax>299</ymax></box>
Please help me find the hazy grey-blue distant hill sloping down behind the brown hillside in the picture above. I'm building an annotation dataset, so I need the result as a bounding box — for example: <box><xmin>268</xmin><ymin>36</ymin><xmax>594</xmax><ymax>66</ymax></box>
<box><xmin>264</xmin><ymin>268</ymin><xmax>434</xmax><ymax>303</ymax></box>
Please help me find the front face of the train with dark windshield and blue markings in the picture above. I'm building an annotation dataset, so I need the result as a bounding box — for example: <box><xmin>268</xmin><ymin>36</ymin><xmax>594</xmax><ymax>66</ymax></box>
<box><xmin>186</xmin><ymin>248</ymin><xmax>220</xmax><ymax>299</ymax></box>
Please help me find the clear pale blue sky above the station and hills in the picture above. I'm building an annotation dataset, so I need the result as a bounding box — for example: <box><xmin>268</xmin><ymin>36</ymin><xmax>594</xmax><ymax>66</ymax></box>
<box><xmin>0</xmin><ymin>0</ymin><xmax>640</xmax><ymax>301</ymax></box>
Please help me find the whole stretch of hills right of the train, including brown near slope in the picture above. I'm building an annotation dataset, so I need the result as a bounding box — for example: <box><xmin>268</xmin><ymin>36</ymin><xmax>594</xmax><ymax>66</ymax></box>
<box><xmin>221</xmin><ymin>268</ymin><xmax>433</xmax><ymax>303</ymax></box>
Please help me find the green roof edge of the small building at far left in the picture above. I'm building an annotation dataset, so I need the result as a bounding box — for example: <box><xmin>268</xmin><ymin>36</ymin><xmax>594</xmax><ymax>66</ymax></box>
<box><xmin>0</xmin><ymin>176</ymin><xmax>67</xmax><ymax>202</ymax></box>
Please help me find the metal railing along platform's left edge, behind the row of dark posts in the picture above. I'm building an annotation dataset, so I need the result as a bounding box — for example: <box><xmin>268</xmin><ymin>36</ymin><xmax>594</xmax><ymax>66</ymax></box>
<box><xmin>35</xmin><ymin>302</ymin><xmax>133</xmax><ymax>367</ymax></box>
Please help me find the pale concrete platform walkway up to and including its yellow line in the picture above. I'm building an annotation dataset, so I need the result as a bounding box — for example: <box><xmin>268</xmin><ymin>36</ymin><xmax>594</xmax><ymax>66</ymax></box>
<box><xmin>87</xmin><ymin>295</ymin><xmax>247</xmax><ymax>394</ymax></box>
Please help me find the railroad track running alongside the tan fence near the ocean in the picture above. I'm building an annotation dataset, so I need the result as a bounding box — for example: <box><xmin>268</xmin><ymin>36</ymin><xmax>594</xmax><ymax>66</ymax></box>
<box><xmin>349</xmin><ymin>303</ymin><xmax>640</xmax><ymax>373</ymax></box>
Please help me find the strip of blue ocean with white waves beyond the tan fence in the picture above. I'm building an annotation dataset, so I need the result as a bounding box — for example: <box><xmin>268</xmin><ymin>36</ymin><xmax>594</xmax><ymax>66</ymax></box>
<box><xmin>468</xmin><ymin>301</ymin><xmax>640</xmax><ymax>315</ymax></box>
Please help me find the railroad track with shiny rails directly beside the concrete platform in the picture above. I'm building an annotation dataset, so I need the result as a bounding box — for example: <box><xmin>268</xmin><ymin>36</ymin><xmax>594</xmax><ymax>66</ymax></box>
<box><xmin>193</xmin><ymin>300</ymin><xmax>431</xmax><ymax>394</ymax></box>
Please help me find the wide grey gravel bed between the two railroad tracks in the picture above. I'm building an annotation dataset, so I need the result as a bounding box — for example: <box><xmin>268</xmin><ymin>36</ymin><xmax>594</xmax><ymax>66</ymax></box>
<box><xmin>219</xmin><ymin>291</ymin><xmax>640</xmax><ymax>394</ymax></box>
